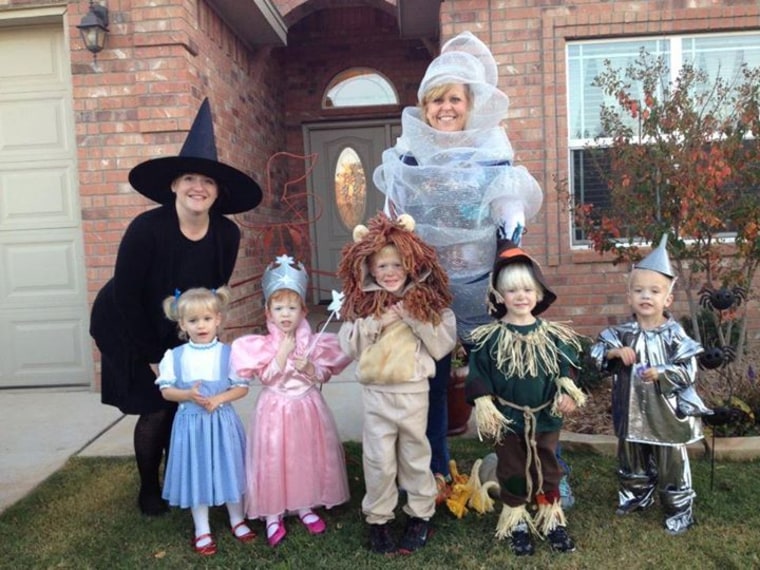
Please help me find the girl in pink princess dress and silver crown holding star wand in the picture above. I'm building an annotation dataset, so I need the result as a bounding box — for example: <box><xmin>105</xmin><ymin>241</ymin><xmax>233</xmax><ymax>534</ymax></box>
<box><xmin>230</xmin><ymin>255</ymin><xmax>351</xmax><ymax>546</ymax></box>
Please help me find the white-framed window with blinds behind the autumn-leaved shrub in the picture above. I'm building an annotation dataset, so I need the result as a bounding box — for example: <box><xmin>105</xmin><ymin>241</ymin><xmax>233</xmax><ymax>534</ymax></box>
<box><xmin>567</xmin><ymin>32</ymin><xmax>760</xmax><ymax>244</ymax></box>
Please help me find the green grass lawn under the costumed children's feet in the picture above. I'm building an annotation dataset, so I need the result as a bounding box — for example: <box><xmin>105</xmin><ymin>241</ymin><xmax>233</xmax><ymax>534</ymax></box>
<box><xmin>0</xmin><ymin>439</ymin><xmax>760</xmax><ymax>570</ymax></box>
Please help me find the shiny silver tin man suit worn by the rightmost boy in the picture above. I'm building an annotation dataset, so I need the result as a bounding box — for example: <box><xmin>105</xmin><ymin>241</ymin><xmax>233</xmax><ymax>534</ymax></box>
<box><xmin>591</xmin><ymin>316</ymin><xmax>703</xmax><ymax>533</ymax></box>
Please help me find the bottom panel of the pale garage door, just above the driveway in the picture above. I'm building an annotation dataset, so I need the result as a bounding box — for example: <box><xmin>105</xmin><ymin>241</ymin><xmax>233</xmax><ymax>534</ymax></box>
<box><xmin>0</xmin><ymin>308</ymin><xmax>90</xmax><ymax>386</ymax></box>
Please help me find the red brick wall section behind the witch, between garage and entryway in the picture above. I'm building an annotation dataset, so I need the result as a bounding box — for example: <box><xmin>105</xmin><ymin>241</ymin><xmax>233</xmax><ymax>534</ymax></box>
<box><xmin>70</xmin><ymin>0</ymin><xmax>285</xmax><ymax>382</ymax></box>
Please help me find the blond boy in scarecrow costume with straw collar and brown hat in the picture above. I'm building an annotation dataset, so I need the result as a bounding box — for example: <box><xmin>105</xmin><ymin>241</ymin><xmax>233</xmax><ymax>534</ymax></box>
<box><xmin>466</xmin><ymin>240</ymin><xmax>586</xmax><ymax>556</ymax></box>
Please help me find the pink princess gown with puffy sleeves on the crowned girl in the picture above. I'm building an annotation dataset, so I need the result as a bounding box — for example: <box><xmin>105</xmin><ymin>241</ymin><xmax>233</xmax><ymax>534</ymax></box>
<box><xmin>230</xmin><ymin>320</ymin><xmax>351</xmax><ymax>519</ymax></box>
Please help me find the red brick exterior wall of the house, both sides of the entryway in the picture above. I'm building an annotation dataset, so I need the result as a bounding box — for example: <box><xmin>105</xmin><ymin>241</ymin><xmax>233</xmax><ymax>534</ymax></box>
<box><xmin>17</xmin><ymin>0</ymin><xmax>760</xmax><ymax>386</ymax></box>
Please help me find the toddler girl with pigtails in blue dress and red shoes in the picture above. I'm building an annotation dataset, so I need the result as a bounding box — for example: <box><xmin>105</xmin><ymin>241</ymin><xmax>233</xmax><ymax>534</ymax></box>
<box><xmin>156</xmin><ymin>287</ymin><xmax>256</xmax><ymax>556</ymax></box>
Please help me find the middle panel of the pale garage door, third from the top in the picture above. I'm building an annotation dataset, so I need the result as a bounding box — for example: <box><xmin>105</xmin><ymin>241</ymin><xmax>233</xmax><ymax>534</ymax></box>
<box><xmin>0</xmin><ymin>161</ymin><xmax>78</xmax><ymax>225</ymax></box>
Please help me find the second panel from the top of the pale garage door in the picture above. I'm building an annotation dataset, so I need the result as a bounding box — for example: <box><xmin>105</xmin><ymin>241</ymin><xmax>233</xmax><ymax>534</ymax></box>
<box><xmin>0</xmin><ymin>96</ymin><xmax>71</xmax><ymax>156</ymax></box>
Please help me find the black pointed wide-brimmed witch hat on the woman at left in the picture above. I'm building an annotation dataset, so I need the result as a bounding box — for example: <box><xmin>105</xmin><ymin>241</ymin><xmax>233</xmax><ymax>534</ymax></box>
<box><xmin>129</xmin><ymin>98</ymin><xmax>261</xmax><ymax>214</ymax></box>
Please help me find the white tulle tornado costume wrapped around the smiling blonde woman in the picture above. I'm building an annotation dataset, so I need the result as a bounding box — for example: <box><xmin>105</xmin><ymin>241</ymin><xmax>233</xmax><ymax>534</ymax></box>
<box><xmin>374</xmin><ymin>32</ymin><xmax>543</xmax><ymax>340</ymax></box>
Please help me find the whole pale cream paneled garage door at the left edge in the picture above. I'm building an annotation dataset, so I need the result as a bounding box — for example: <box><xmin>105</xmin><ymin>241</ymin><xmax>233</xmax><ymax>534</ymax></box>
<box><xmin>0</xmin><ymin>24</ymin><xmax>93</xmax><ymax>388</ymax></box>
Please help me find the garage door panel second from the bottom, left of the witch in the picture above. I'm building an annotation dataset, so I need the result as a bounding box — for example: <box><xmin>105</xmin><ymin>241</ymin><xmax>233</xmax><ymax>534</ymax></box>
<box><xmin>0</xmin><ymin>226</ymin><xmax>82</xmax><ymax>309</ymax></box>
